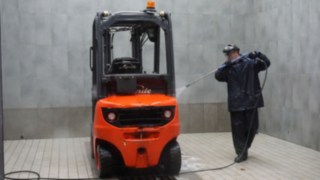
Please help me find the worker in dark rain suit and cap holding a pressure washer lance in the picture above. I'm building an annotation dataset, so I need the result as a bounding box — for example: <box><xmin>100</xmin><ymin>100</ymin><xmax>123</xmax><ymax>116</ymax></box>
<box><xmin>215</xmin><ymin>44</ymin><xmax>270</xmax><ymax>163</ymax></box>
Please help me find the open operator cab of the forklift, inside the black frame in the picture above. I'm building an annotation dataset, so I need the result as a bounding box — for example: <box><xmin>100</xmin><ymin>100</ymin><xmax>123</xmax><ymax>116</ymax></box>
<box><xmin>94</xmin><ymin>16</ymin><xmax>175</xmax><ymax>97</ymax></box>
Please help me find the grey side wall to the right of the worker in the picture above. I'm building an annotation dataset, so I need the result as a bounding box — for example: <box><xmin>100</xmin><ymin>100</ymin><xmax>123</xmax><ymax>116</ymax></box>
<box><xmin>250</xmin><ymin>0</ymin><xmax>320</xmax><ymax>150</ymax></box>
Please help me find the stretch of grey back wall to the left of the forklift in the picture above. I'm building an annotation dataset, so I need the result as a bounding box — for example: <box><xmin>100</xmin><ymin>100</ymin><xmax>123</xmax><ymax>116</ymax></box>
<box><xmin>1</xmin><ymin>0</ymin><xmax>98</xmax><ymax>139</ymax></box>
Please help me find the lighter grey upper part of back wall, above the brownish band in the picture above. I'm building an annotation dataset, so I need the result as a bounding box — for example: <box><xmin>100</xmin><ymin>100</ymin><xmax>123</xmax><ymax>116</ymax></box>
<box><xmin>2</xmin><ymin>0</ymin><xmax>243</xmax><ymax>108</ymax></box>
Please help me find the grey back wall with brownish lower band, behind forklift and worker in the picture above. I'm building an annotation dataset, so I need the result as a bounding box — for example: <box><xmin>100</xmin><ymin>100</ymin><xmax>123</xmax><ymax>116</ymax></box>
<box><xmin>1</xmin><ymin>0</ymin><xmax>251</xmax><ymax>139</ymax></box>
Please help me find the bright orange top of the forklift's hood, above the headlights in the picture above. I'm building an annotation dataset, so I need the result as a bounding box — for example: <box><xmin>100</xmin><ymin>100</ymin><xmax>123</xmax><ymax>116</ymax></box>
<box><xmin>100</xmin><ymin>94</ymin><xmax>177</xmax><ymax>108</ymax></box>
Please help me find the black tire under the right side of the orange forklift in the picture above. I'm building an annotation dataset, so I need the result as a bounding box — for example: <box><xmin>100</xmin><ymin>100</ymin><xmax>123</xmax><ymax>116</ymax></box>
<box><xmin>161</xmin><ymin>141</ymin><xmax>181</xmax><ymax>175</ymax></box>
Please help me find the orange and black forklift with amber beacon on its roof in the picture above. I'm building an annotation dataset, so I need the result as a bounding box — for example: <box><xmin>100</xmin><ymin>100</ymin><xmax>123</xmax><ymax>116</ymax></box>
<box><xmin>90</xmin><ymin>1</ymin><xmax>181</xmax><ymax>178</ymax></box>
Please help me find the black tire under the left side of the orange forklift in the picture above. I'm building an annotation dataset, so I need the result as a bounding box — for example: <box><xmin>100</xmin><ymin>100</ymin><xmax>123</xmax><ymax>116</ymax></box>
<box><xmin>97</xmin><ymin>146</ymin><xmax>114</xmax><ymax>178</ymax></box>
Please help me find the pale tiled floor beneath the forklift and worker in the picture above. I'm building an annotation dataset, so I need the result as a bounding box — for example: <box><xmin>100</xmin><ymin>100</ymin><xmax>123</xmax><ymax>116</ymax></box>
<box><xmin>4</xmin><ymin>133</ymin><xmax>320</xmax><ymax>180</ymax></box>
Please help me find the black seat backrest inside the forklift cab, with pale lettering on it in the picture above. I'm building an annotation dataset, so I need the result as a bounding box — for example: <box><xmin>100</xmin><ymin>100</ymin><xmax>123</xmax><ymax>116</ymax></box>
<box><xmin>111</xmin><ymin>57</ymin><xmax>142</xmax><ymax>74</ymax></box>
